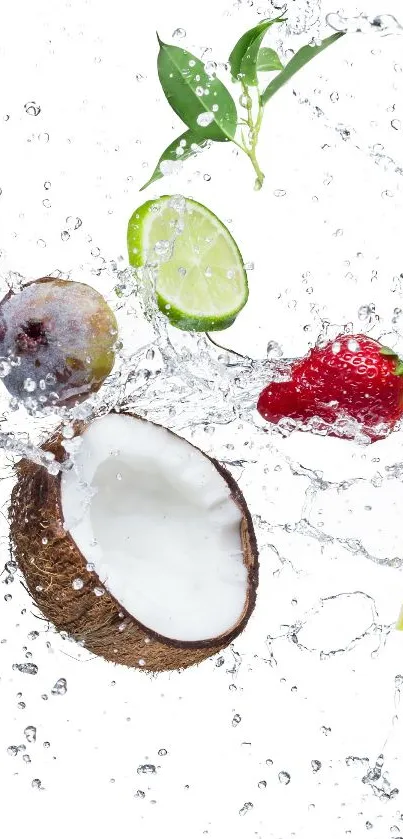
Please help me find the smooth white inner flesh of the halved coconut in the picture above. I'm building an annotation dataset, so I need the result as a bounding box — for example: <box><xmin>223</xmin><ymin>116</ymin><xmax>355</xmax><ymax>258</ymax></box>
<box><xmin>61</xmin><ymin>414</ymin><xmax>248</xmax><ymax>643</ymax></box>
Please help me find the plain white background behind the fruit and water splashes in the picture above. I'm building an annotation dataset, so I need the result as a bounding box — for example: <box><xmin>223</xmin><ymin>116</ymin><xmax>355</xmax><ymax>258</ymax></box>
<box><xmin>0</xmin><ymin>0</ymin><xmax>403</xmax><ymax>839</ymax></box>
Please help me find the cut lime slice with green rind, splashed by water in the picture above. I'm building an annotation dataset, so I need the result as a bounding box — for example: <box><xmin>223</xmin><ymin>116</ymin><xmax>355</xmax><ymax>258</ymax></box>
<box><xmin>127</xmin><ymin>195</ymin><xmax>248</xmax><ymax>332</ymax></box>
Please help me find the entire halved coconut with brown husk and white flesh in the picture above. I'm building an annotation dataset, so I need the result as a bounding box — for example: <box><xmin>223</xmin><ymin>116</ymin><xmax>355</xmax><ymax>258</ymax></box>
<box><xmin>10</xmin><ymin>414</ymin><xmax>258</xmax><ymax>671</ymax></box>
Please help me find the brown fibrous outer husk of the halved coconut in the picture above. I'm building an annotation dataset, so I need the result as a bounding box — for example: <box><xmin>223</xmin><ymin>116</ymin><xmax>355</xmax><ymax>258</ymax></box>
<box><xmin>9</xmin><ymin>420</ymin><xmax>258</xmax><ymax>672</ymax></box>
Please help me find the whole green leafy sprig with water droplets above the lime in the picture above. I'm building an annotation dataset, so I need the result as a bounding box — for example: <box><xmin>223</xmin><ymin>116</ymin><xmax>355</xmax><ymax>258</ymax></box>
<box><xmin>141</xmin><ymin>16</ymin><xmax>344</xmax><ymax>189</ymax></box>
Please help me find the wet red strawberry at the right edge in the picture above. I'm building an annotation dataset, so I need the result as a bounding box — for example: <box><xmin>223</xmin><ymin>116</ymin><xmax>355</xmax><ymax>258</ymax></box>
<box><xmin>257</xmin><ymin>335</ymin><xmax>403</xmax><ymax>441</ymax></box>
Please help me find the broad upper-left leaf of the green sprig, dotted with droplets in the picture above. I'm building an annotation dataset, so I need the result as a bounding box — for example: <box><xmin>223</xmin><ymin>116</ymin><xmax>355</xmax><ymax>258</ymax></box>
<box><xmin>158</xmin><ymin>39</ymin><xmax>237</xmax><ymax>142</ymax></box>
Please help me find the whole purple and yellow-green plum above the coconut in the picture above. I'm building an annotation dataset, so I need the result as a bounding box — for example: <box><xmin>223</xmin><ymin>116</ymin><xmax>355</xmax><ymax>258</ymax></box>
<box><xmin>0</xmin><ymin>277</ymin><xmax>118</xmax><ymax>408</ymax></box>
